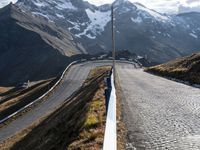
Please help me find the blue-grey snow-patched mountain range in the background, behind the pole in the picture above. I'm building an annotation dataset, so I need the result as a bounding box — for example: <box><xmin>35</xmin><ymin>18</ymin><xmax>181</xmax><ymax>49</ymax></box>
<box><xmin>17</xmin><ymin>0</ymin><xmax>200</xmax><ymax>62</ymax></box>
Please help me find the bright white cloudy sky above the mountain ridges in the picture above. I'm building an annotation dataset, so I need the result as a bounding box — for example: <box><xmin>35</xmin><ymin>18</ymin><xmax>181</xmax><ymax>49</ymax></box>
<box><xmin>0</xmin><ymin>0</ymin><xmax>200</xmax><ymax>13</ymax></box>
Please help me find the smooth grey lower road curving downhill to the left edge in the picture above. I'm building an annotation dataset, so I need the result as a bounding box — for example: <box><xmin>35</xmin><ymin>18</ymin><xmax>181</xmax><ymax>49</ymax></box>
<box><xmin>0</xmin><ymin>61</ymin><xmax>115</xmax><ymax>142</ymax></box>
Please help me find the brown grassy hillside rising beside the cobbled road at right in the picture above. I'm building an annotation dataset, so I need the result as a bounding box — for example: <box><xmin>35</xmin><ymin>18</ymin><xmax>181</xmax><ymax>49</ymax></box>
<box><xmin>145</xmin><ymin>53</ymin><xmax>200</xmax><ymax>84</ymax></box>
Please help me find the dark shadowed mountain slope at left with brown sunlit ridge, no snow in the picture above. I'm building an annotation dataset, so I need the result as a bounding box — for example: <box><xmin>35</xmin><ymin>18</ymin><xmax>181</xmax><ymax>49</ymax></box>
<box><xmin>0</xmin><ymin>4</ymin><xmax>86</xmax><ymax>86</ymax></box>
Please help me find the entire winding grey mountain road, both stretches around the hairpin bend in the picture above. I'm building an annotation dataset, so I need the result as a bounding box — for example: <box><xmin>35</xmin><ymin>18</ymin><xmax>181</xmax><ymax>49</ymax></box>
<box><xmin>0</xmin><ymin>61</ymin><xmax>200</xmax><ymax>150</ymax></box>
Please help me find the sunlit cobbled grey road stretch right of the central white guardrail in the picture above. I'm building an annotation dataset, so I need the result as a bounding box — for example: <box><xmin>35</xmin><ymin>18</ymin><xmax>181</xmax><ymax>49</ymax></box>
<box><xmin>117</xmin><ymin>65</ymin><xmax>200</xmax><ymax>150</ymax></box>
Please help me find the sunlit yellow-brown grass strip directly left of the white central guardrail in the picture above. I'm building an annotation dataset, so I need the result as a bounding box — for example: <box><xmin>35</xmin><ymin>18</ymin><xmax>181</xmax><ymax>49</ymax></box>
<box><xmin>68</xmin><ymin>83</ymin><xmax>106</xmax><ymax>150</ymax></box>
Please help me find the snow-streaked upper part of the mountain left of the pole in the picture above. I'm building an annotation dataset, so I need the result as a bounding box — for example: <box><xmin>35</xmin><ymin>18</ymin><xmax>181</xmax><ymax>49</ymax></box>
<box><xmin>17</xmin><ymin>0</ymin><xmax>107</xmax><ymax>39</ymax></box>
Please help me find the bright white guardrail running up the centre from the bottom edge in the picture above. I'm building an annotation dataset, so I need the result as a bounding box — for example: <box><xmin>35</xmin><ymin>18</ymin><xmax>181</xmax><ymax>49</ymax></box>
<box><xmin>103</xmin><ymin>73</ymin><xmax>117</xmax><ymax>150</ymax></box>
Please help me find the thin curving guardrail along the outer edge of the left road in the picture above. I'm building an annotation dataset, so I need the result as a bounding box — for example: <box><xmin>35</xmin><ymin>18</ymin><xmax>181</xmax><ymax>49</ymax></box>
<box><xmin>0</xmin><ymin>61</ymin><xmax>77</xmax><ymax>124</ymax></box>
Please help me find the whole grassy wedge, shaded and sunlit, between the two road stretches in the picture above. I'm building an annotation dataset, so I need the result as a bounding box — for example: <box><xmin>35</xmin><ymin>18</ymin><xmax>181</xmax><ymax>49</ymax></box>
<box><xmin>0</xmin><ymin>66</ymin><xmax>111</xmax><ymax>150</ymax></box>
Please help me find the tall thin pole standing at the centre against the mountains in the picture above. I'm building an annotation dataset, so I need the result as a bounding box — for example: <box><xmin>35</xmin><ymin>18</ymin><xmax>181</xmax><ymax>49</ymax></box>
<box><xmin>111</xmin><ymin>4</ymin><xmax>115</xmax><ymax>75</ymax></box>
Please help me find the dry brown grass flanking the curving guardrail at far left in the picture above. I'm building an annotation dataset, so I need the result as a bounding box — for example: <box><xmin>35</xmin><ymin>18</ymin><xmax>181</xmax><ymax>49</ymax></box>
<box><xmin>0</xmin><ymin>78</ymin><xmax>58</xmax><ymax>129</ymax></box>
